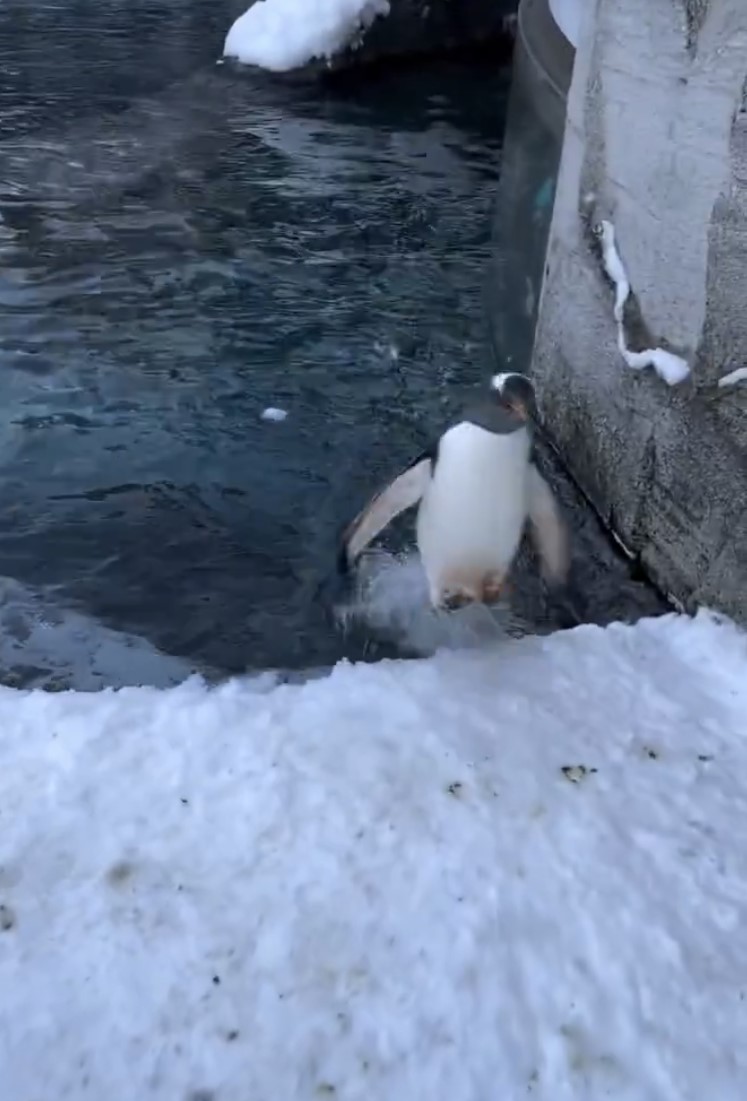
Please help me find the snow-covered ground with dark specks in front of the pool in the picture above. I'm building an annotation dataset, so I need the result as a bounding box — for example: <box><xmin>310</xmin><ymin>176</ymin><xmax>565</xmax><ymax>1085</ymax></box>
<box><xmin>0</xmin><ymin>614</ymin><xmax>747</xmax><ymax>1101</ymax></box>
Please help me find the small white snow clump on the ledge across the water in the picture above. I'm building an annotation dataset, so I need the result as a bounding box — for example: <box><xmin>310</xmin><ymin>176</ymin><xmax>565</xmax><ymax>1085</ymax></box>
<box><xmin>224</xmin><ymin>0</ymin><xmax>389</xmax><ymax>73</ymax></box>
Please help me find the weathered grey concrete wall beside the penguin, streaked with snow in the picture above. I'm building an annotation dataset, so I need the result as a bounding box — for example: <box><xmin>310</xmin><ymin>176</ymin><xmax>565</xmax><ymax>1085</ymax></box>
<box><xmin>532</xmin><ymin>0</ymin><xmax>747</xmax><ymax>621</ymax></box>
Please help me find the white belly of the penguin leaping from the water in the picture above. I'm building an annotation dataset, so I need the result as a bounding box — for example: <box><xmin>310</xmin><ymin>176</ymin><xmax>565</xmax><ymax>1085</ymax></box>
<box><xmin>418</xmin><ymin>422</ymin><xmax>530</xmax><ymax>603</ymax></box>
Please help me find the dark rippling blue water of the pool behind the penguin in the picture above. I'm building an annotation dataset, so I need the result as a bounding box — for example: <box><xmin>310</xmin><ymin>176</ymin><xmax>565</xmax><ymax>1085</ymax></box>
<box><xmin>0</xmin><ymin>0</ymin><xmax>665</xmax><ymax>683</ymax></box>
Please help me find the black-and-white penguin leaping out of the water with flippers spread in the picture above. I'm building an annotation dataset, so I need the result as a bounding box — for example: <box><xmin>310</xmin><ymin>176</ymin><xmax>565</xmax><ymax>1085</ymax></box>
<box><xmin>338</xmin><ymin>372</ymin><xmax>570</xmax><ymax>610</ymax></box>
